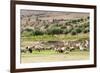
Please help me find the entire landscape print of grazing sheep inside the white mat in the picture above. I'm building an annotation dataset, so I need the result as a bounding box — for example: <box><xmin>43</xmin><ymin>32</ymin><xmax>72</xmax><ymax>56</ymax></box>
<box><xmin>20</xmin><ymin>10</ymin><xmax>90</xmax><ymax>63</ymax></box>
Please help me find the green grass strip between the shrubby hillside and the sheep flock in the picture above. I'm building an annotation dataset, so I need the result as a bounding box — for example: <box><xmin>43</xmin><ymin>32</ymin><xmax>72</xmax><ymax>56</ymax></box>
<box><xmin>21</xmin><ymin>34</ymin><xmax>89</xmax><ymax>41</ymax></box>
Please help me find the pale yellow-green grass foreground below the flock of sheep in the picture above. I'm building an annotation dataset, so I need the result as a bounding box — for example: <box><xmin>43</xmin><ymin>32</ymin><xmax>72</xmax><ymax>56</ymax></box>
<box><xmin>21</xmin><ymin>50</ymin><xmax>89</xmax><ymax>63</ymax></box>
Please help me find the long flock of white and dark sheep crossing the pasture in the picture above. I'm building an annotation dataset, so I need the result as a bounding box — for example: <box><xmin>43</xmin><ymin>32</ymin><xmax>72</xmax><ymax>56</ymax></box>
<box><xmin>21</xmin><ymin>40</ymin><xmax>89</xmax><ymax>54</ymax></box>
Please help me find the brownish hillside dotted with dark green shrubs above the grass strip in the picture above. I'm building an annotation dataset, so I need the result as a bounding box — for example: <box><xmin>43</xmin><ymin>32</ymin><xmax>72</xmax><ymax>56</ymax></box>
<box><xmin>21</xmin><ymin>10</ymin><xmax>89</xmax><ymax>36</ymax></box>
